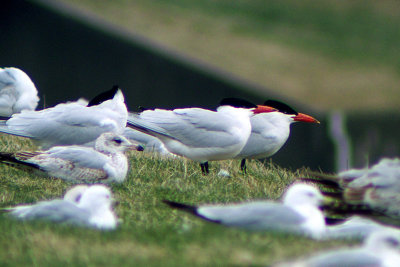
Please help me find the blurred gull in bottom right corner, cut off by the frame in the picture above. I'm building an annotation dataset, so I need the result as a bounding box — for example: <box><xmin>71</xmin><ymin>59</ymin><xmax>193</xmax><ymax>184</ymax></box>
<box><xmin>274</xmin><ymin>231</ymin><xmax>400</xmax><ymax>267</ymax></box>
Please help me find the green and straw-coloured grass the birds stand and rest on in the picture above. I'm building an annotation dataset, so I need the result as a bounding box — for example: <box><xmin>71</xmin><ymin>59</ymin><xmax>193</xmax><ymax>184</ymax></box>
<box><xmin>0</xmin><ymin>136</ymin><xmax>352</xmax><ymax>266</ymax></box>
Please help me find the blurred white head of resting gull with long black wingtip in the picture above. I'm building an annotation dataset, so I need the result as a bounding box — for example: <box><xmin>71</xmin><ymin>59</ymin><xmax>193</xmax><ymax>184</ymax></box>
<box><xmin>283</xmin><ymin>183</ymin><xmax>324</xmax><ymax>207</ymax></box>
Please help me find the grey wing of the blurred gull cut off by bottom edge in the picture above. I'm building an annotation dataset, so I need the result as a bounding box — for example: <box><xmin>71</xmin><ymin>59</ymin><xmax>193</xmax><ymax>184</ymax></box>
<box><xmin>306</xmin><ymin>250</ymin><xmax>382</xmax><ymax>267</ymax></box>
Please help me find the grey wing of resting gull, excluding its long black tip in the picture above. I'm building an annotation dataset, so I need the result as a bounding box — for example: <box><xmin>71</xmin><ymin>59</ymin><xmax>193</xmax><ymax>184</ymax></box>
<box><xmin>198</xmin><ymin>201</ymin><xmax>304</xmax><ymax>231</ymax></box>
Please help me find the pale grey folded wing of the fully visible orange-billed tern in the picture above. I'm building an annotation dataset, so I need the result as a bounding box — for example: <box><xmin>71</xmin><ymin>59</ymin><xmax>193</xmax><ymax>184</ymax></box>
<box><xmin>140</xmin><ymin>108</ymin><xmax>242</xmax><ymax>147</ymax></box>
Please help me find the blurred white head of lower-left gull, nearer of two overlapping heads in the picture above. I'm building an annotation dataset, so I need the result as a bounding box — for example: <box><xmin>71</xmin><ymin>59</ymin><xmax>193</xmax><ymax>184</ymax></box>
<box><xmin>78</xmin><ymin>185</ymin><xmax>112</xmax><ymax>212</ymax></box>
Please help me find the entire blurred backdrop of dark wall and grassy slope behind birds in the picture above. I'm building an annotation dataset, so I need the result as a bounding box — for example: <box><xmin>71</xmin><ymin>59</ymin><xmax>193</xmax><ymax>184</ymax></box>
<box><xmin>0</xmin><ymin>0</ymin><xmax>400</xmax><ymax>172</ymax></box>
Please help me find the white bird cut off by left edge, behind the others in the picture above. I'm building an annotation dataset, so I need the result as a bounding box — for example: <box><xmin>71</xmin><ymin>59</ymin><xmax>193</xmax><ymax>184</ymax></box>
<box><xmin>0</xmin><ymin>68</ymin><xmax>39</xmax><ymax>117</ymax></box>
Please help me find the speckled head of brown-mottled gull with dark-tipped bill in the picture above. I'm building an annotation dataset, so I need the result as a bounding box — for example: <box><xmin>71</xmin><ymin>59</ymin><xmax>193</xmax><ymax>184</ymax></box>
<box><xmin>95</xmin><ymin>133</ymin><xmax>133</xmax><ymax>153</ymax></box>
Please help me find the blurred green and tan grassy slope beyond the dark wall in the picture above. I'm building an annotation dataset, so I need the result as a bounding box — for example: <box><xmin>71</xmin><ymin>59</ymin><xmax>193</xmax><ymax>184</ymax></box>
<box><xmin>58</xmin><ymin>0</ymin><xmax>400</xmax><ymax>111</ymax></box>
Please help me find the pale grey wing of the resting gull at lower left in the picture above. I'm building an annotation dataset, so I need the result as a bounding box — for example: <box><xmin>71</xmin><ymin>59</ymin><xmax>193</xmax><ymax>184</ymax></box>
<box><xmin>11</xmin><ymin>200</ymin><xmax>89</xmax><ymax>224</ymax></box>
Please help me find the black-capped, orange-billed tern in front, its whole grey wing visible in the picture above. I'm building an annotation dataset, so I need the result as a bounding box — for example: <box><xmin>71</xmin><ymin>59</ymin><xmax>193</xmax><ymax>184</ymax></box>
<box><xmin>128</xmin><ymin>98</ymin><xmax>275</xmax><ymax>174</ymax></box>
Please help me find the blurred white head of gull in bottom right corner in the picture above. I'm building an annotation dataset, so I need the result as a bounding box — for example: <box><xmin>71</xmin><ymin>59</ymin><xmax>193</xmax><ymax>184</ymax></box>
<box><xmin>364</xmin><ymin>230</ymin><xmax>400</xmax><ymax>253</ymax></box>
